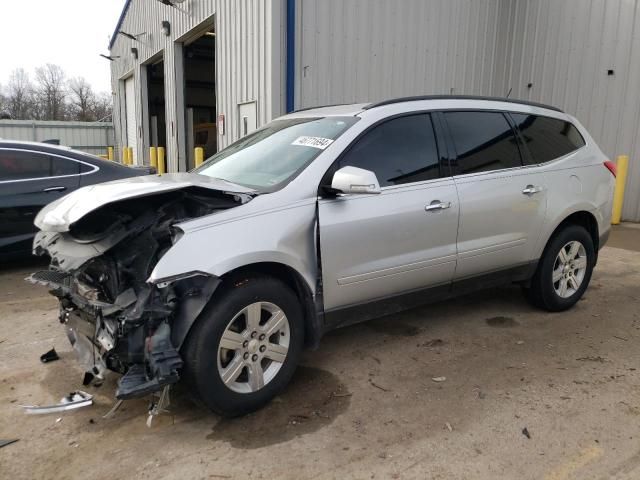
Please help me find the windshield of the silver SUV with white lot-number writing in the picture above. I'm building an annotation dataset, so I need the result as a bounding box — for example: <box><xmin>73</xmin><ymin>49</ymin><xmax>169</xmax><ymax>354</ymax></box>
<box><xmin>193</xmin><ymin>117</ymin><xmax>358</xmax><ymax>192</ymax></box>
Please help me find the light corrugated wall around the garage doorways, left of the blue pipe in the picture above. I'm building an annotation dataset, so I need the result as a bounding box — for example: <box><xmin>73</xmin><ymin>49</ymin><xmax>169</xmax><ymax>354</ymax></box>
<box><xmin>111</xmin><ymin>0</ymin><xmax>284</xmax><ymax>171</ymax></box>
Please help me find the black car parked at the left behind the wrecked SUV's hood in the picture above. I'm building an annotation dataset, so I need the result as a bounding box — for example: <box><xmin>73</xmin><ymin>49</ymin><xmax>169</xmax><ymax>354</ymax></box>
<box><xmin>0</xmin><ymin>140</ymin><xmax>155</xmax><ymax>262</ymax></box>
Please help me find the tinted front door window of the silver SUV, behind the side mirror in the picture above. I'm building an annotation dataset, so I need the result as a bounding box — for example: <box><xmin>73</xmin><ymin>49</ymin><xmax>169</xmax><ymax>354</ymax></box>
<box><xmin>338</xmin><ymin>114</ymin><xmax>440</xmax><ymax>187</ymax></box>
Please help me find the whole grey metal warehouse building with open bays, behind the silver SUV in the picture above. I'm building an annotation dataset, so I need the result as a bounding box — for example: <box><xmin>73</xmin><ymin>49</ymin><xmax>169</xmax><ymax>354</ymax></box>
<box><xmin>110</xmin><ymin>0</ymin><xmax>640</xmax><ymax>221</ymax></box>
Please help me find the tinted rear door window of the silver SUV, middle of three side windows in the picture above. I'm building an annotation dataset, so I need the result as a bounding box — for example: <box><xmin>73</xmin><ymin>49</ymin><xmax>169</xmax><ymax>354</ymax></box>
<box><xmin>444</xmin><ymin>112</ymin><xmax>522</xmax><ymax>175</ymax></box>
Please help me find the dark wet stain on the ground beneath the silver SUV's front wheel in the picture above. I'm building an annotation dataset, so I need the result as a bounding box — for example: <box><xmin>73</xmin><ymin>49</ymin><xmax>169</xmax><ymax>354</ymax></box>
<box><xmin>207</xmin><ymin>367</ymin><xmax>351</xmax><ymax>449</ymax></box>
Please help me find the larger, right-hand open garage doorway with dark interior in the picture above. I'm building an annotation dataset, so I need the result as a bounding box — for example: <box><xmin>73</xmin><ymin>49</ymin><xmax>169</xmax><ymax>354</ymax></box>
<box><xmin>183</xmin><ymin>26</ymin><xmax>218</xmax><ymax>170</ymax></box>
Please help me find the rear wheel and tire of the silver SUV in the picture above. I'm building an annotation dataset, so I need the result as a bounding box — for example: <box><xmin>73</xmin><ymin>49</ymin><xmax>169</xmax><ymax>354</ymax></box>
<box><xmin>525</xmin><ymin>225</ymin><xmax>596</xmax><ymax>312</ymax></box>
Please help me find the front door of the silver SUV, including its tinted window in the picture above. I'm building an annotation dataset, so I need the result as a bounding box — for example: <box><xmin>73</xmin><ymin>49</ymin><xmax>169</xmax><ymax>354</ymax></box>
<box><xmin>319</xmin><ymin>114</ymin><xmax>458</xmax><ymax>312</ymax></box>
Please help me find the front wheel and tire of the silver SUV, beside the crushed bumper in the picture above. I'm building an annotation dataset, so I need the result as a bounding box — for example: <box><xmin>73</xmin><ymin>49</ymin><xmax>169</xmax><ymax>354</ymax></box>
<box><xmin>183</xmin><ymin>276</ymin><xmax>304</xmax><ymax>417</ymax></box>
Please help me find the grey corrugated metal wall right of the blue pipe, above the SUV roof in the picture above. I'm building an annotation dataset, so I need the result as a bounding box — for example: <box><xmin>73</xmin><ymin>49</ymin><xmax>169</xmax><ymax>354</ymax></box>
<box><xmin>296</xmin><ymin>0</ymin><xmax>640</xmax><ymax>221</ymax></box>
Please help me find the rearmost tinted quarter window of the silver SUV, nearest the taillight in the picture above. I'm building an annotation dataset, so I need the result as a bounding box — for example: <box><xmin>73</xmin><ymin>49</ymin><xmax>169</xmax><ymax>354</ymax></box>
<box><xmin>511</xmin><ymin>113</ymin><xmax>585</xmax><ymax>163</ymax></box>
